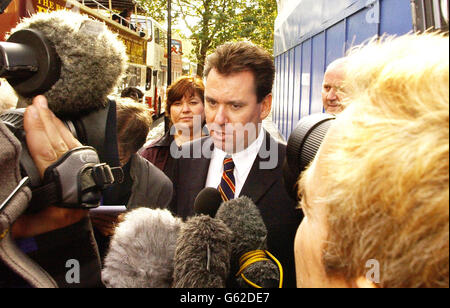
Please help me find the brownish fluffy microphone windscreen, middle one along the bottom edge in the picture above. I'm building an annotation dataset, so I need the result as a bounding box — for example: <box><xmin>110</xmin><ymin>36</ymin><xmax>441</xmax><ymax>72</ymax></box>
<box><xmin>173</xmin><ymin>215</ymin><xmax>231</xmax><ymax>288</ymax></box>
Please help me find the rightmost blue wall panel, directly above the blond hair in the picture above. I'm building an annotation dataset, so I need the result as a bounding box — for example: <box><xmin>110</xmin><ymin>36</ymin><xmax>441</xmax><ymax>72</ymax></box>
<box><xmin>380</xmin><ymin>0</ymin><xmax>413</xmax><ymax>35</ymax></box>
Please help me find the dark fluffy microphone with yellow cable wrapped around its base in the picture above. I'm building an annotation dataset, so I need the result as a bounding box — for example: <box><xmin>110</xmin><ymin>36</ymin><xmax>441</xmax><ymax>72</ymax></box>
<box><xmin>216</xmin><ymin>196</ymin><xmax>283</xmax><ymax>288</ymax></box>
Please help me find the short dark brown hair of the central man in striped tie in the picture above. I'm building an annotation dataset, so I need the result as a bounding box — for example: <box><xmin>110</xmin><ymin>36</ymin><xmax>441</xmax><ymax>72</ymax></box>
<box><xmin>203</xmin><ymin>42</ymin><xmax>275</xmax><ymax>103</ymax></box>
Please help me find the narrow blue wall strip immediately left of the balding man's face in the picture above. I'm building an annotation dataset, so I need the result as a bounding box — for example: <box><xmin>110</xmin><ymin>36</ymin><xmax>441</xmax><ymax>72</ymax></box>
<box><xmin>310</xmin><ymin>32</ymin><xmax>325</xmax><ymax>113</ymax></box>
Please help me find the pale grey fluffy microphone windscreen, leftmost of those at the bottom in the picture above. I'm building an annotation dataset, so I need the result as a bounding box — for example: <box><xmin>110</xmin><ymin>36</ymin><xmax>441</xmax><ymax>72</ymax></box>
<box><xmin>102</xmin><ymin>208</ymin><xmax>182</xmax><ymax>288</ymax></box>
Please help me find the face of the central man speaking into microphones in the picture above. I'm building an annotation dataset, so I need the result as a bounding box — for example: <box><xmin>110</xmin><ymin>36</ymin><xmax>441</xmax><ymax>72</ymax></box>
<box><xmin>205</xmin><ymin>69</ymin><xmax>272</xmax><ymax>153</ymax></box>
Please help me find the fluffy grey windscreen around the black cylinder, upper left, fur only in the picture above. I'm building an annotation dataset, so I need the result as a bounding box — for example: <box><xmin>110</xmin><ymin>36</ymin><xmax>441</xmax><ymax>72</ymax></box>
<box><xmin>11</xmin><ymin>10</ymin><xmax>127</xmax><ymax>117</ymax></box>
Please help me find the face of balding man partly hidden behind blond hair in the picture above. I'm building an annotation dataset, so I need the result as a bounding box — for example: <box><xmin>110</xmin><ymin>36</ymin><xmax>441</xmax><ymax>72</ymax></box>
<box><xmin>322</xmin><ymin>67</ymin><xmax>344</xmax><ymax>114</ymax></box>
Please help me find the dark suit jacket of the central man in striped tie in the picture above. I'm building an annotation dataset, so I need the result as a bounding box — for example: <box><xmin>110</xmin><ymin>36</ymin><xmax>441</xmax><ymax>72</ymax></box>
<box><xmin>173</xmin><ymin>132</ymin><xmax>303</xmax><ymax>287</ymax></box>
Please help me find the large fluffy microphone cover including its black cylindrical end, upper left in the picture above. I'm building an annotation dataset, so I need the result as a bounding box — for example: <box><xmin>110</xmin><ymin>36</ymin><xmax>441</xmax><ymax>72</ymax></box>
<box><xmin>0</xmin><ymin>10</ymin><xmax>127</xmax><ymax>118</ymax></box>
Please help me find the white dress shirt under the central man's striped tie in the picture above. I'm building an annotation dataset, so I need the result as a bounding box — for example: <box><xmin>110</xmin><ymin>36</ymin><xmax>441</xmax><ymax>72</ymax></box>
<box><xmin>205</xmin><ymin>129</ymin><xmax>265</xmax><ymax>198</ymax></box>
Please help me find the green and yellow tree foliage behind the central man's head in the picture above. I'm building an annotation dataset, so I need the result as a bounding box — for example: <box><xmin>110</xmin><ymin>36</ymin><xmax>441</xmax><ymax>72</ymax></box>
<box><xmin>136</xmin><ymin>0</ymin><xmax>277</xmax><ymax>72</ymax></box>
